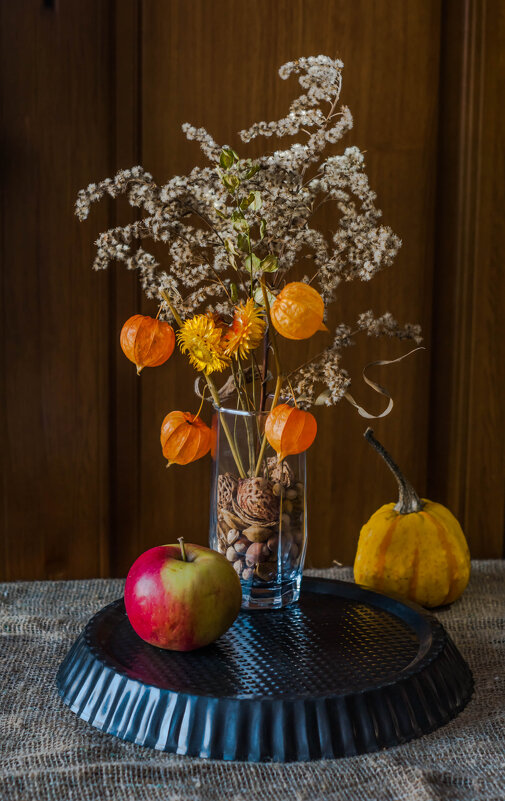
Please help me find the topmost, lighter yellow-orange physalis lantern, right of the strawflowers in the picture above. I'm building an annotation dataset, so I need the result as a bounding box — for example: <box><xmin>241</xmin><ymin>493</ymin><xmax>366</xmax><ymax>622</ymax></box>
<box><xmin>270</xmin><ymin>281</ymin><xmax>328</xmax><ymax>339</ymax></box>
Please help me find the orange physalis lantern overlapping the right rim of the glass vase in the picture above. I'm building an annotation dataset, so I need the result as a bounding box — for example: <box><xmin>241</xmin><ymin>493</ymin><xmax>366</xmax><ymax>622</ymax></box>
<box><xmin>265</xmin><ymin>403</ymin><xmax>317</xmax><ymax>462</ymax></box>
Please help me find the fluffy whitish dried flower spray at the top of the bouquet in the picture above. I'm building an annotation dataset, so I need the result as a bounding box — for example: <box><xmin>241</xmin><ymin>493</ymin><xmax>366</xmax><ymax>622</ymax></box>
<box><xmin>76</xmin><ymin>56</ymin><xmax>421</xmax><ymax>406</ymax></box>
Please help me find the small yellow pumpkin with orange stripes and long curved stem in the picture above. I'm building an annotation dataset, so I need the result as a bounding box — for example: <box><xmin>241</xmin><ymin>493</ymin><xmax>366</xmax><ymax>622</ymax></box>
<box><xmin>354</xmin><ymin>428</ymin><xmax>470</xmax><ymax>607</ymax></box>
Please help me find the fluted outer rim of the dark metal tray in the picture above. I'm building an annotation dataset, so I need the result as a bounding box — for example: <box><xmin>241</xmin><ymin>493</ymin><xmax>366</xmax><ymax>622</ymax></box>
<box><xmin>57</xmin><ymin>588</ymin><xmax>473</xmax><ymax>762</ymax></box>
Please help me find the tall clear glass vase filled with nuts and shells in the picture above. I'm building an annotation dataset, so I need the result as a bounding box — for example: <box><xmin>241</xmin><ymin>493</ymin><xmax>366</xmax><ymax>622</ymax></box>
<box><xmin>210</xmin><ymin>408</ymin><xmax>307</xmax><ymax>609</ymax></box>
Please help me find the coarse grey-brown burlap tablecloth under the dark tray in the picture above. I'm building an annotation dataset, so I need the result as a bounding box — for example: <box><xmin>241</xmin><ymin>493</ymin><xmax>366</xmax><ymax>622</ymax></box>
<box><xmin>0</xmin><ymin>561</ymin><xmax>505</xmax><ymax>801</ymax></box>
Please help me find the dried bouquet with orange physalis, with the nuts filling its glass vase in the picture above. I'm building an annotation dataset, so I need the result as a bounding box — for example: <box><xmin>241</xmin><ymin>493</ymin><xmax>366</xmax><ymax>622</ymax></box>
<box><xmin>76</xmin><ymin>56</ymin><xmax>420</xmax><ymax>608</ymax></box>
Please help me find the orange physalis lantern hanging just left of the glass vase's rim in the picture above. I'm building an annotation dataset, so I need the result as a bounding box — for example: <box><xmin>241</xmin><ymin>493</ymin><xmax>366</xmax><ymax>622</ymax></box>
<box><xmin>160</xmin><ymin>412</ymin><xmax>212</xmax><ymax>465</ymax></box>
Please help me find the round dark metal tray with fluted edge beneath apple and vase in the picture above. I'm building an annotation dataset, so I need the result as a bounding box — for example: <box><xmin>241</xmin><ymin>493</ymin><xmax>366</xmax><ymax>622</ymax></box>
<box><xmin>57</xmin><ymin>578</ymin><xmax>473</xmax><ymax>762</ymax></box>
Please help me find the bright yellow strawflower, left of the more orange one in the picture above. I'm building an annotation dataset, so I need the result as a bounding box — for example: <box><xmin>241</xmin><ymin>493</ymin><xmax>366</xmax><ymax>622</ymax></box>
<box><xmin>177</xmin><ymin>314</ymin><xmax>230</xmax><ymax>375</ymax></box>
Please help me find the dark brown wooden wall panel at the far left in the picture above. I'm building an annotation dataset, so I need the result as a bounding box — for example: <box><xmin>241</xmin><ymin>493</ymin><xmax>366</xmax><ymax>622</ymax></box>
<box><xmin>0</xmin><ymin>0</ymin><xmax>113</xmax><ymax>579</ymax></box>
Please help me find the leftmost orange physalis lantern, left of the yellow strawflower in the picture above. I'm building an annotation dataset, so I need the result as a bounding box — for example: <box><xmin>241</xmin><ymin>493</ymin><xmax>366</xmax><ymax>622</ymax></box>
<box><xmin>120</xmin><ymin>314</ymin><xmax>175</xmax><ymax>374</ymax></box>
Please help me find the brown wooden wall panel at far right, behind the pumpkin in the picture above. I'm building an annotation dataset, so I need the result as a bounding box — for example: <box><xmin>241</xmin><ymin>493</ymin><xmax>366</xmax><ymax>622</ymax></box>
<box><xmin>429</xmin><ymin>0</ymin><xmax>505</xmax><ymax>557</ymax></box>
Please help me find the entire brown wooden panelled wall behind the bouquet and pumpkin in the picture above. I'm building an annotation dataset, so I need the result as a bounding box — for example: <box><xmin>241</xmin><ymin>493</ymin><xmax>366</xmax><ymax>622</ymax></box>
<box><xmin>0</xmin><ymin>0</ymin><xmax>505</xmax><ymax>579</ymax></box>
